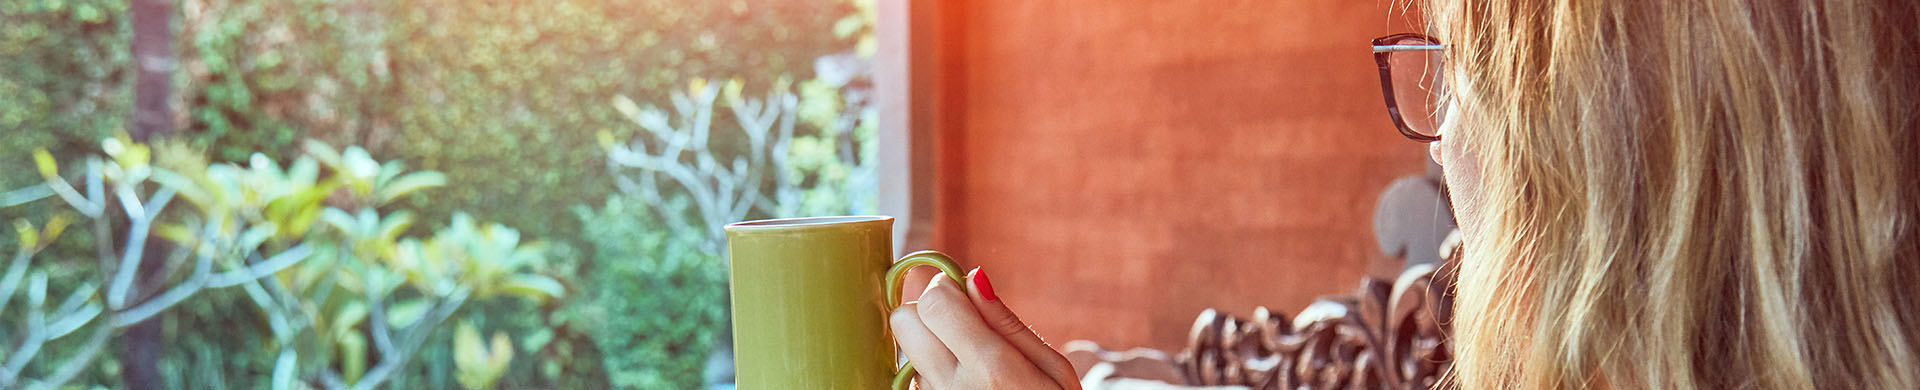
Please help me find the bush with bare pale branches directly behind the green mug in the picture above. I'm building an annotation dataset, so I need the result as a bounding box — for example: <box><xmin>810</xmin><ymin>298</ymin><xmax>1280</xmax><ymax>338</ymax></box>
<box><xmin>574</xmin><ymin>69</ymin><xmax>876</xmax><ymax>388</ymax></box>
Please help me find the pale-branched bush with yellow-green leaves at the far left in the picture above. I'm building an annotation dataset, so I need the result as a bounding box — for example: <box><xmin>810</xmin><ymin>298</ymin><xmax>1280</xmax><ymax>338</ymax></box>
<box><xmin>0</xmin><ymin>138</ymin><xmax>566</xmax><ymax>388</ymax></box>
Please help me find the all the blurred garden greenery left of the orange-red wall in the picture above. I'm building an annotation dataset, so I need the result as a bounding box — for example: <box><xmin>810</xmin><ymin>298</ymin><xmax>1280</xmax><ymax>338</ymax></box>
<box><xmin>0</xmin><ymin>0</ymin><xmax>876</xmax><ymax>388</ymax></box>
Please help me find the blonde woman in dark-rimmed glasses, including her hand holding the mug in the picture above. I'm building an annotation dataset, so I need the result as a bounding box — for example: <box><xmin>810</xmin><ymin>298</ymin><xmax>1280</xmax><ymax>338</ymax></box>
<box><xmin>893</xmin><ymin>0</ymin><xmax>1920</xmax><ymax>390</ymax></box>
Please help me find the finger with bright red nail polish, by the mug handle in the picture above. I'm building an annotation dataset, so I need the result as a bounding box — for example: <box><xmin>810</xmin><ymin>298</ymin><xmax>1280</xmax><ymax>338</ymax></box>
<box><xmin>966</xmin><ymin>267</ymin><xmax>1079</xmax><ymax>388</ymax></box>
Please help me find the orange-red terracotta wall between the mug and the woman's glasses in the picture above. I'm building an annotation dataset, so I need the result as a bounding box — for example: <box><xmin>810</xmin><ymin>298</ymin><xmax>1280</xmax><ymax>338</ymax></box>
<box><xmin>914</xmin><ymin>0</ymin><xmax>1425</xmax><ymax>350</ymax></box>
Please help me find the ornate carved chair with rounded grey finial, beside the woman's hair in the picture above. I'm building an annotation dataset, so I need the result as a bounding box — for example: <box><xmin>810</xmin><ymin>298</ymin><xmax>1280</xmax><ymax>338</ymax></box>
<box><xmin>1064</xmin><ymin>163</ymin><xmax>1457</xmax><ymax>390</ymax></box>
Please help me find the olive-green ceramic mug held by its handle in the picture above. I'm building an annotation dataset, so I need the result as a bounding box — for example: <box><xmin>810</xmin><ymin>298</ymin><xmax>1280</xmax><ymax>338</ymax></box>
<box><xmin>726</xmin><ymin>217</ymin><xmax>966</xmax><ymax>390</ymax></box>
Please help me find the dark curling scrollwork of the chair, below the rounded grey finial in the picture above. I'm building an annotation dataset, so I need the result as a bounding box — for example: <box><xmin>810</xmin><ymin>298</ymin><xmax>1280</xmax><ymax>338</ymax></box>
<box><xmin>1173</xmin><ymin>265</ymin><xmax>1453</xmax><ymax>390</ymax></box>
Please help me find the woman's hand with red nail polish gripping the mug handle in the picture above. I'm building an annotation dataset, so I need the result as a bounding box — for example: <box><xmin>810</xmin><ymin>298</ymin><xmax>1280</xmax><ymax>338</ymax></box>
<box><xmin>891</xmin><ymin>269</ymin><xmax>1081</xmax><ymax>390</ymax></box>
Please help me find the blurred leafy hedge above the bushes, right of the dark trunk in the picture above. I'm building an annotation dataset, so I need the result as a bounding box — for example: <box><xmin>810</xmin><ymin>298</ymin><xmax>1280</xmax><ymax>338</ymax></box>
<box><xmin>161</xmin><ymin>0</ymin><xmax>858</xmax><ymax>236</ymax></box>
